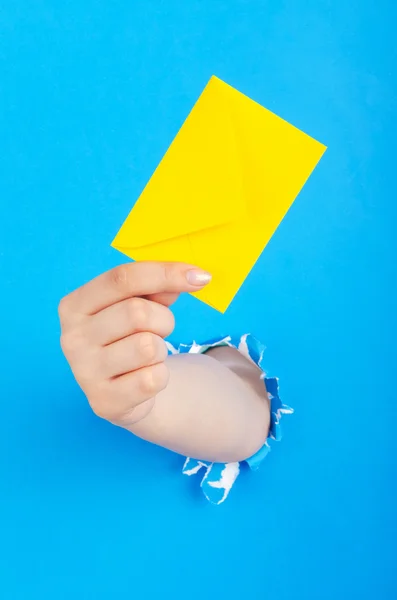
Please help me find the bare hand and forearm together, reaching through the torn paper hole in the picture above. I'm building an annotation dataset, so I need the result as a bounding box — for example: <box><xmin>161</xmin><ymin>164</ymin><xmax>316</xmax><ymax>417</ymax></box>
<box><xmin>59</xmin><ymin>262</ymin><xmax>269</xmax><ymax>462</ymax></box>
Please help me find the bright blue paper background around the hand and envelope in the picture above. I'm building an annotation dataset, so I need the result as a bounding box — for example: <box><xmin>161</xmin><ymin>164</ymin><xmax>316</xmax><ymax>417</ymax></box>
<box><xmin>0</xmin><ymin>0</ymin><xmax>397</xmax><ymax>600</ymax></box>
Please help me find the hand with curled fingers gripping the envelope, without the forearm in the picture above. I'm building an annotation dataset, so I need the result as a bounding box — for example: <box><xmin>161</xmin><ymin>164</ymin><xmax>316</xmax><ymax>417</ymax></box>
<box><xmin>59</xmin><ymin>262</ymin><xmax>211</xmax><ymax>424</ymax></box>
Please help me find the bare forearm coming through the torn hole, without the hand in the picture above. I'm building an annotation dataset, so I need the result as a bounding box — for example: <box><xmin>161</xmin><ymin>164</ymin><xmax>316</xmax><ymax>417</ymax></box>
<box><xmin>119</xmin><ymin>349</ymin><xmax>269</xmax><ymax>462</ymax></box>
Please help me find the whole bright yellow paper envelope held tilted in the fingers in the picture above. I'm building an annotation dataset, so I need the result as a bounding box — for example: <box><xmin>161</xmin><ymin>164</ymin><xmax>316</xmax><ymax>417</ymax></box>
<box><xmin>112</xmin><ymin>77</ymin><xmax>326</xmax><ymax>312</ymax></box>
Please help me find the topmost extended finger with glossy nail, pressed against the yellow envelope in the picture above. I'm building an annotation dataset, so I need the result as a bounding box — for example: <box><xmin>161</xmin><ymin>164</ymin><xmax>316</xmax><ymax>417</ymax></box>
<box><xmin>59</xmin><ymin>262</ymin><xmax>211</xmax><ymax>315</ymax></box>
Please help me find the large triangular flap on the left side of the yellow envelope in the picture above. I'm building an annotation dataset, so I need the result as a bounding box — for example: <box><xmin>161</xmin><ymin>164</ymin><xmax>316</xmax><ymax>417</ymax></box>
<box><xmin>113</xmin><ymin>78</ymin><xmax>241</xmax><ymax>248</ymax></box>
